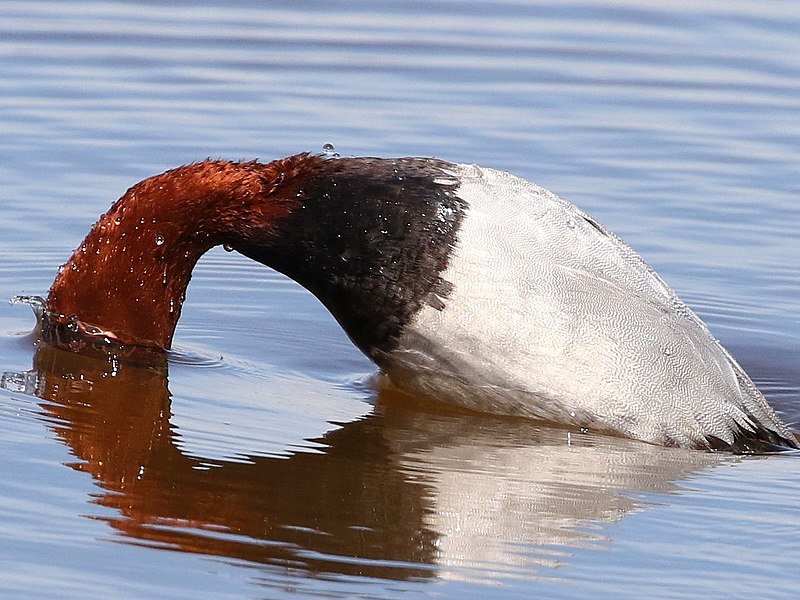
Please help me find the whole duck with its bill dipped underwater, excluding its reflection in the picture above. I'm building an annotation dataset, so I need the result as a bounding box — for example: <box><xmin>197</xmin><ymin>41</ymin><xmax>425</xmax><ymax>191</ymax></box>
<box><xmin>46</xmin><ymin>154</ymin><xmax>797</xmax><ymax>450</ymax></box>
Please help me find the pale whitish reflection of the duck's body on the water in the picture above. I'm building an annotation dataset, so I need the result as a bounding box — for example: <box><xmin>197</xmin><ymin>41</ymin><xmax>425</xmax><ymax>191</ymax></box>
<box><xmin>387</xmin><ymin>417</ymin><xmax>720</xmax><ymax>582</ymax></box>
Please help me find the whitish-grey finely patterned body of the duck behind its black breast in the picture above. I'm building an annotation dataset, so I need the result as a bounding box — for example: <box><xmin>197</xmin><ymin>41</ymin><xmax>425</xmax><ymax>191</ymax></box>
<box><xmin>385</xmin><ymin>166</ymin><xmax>794</xmax><ymax>446</ymax></box>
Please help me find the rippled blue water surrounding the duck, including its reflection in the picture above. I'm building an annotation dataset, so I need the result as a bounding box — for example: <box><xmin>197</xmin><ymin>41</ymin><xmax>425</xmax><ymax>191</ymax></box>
<box><xmin>0</xmin><ymin>0</ymin><xmax>800</xmax><ymax>600</ymax></box>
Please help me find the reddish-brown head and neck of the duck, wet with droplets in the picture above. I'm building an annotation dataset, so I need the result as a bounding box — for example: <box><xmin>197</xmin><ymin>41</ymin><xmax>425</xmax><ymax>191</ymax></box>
<box><xmin>47</xmin><ymin>154</ymin><xmax>323</xmax><ymax>348</ymax></box>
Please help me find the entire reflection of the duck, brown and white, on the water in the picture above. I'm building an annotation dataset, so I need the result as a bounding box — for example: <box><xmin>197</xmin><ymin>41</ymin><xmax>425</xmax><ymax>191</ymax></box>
<box><xmin>5</xmin><ymin>345</ymin><xmax>720</xmax><ymax>579</ymax></box>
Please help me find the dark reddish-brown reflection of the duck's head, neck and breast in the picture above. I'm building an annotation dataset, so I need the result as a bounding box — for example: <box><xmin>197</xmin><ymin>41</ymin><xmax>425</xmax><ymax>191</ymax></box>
<box><xmin>29</xmin><ymin>345</ymin><xmax>435</xmax><ymax>578</ymax></box>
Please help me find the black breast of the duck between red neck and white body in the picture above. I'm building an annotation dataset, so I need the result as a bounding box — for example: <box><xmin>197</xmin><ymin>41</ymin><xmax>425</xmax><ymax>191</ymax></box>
<box><xmin>236</xmin><ymin>158</ymin><xmax>465</xmax><ymax>357</ymax></box>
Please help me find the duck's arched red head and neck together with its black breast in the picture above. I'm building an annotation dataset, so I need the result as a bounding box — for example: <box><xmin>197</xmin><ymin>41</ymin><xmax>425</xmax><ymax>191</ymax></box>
<box><xmin>45</xmin><ymin>154</ymin><xmax>465</xmax><ymax>363</ymax></box>
